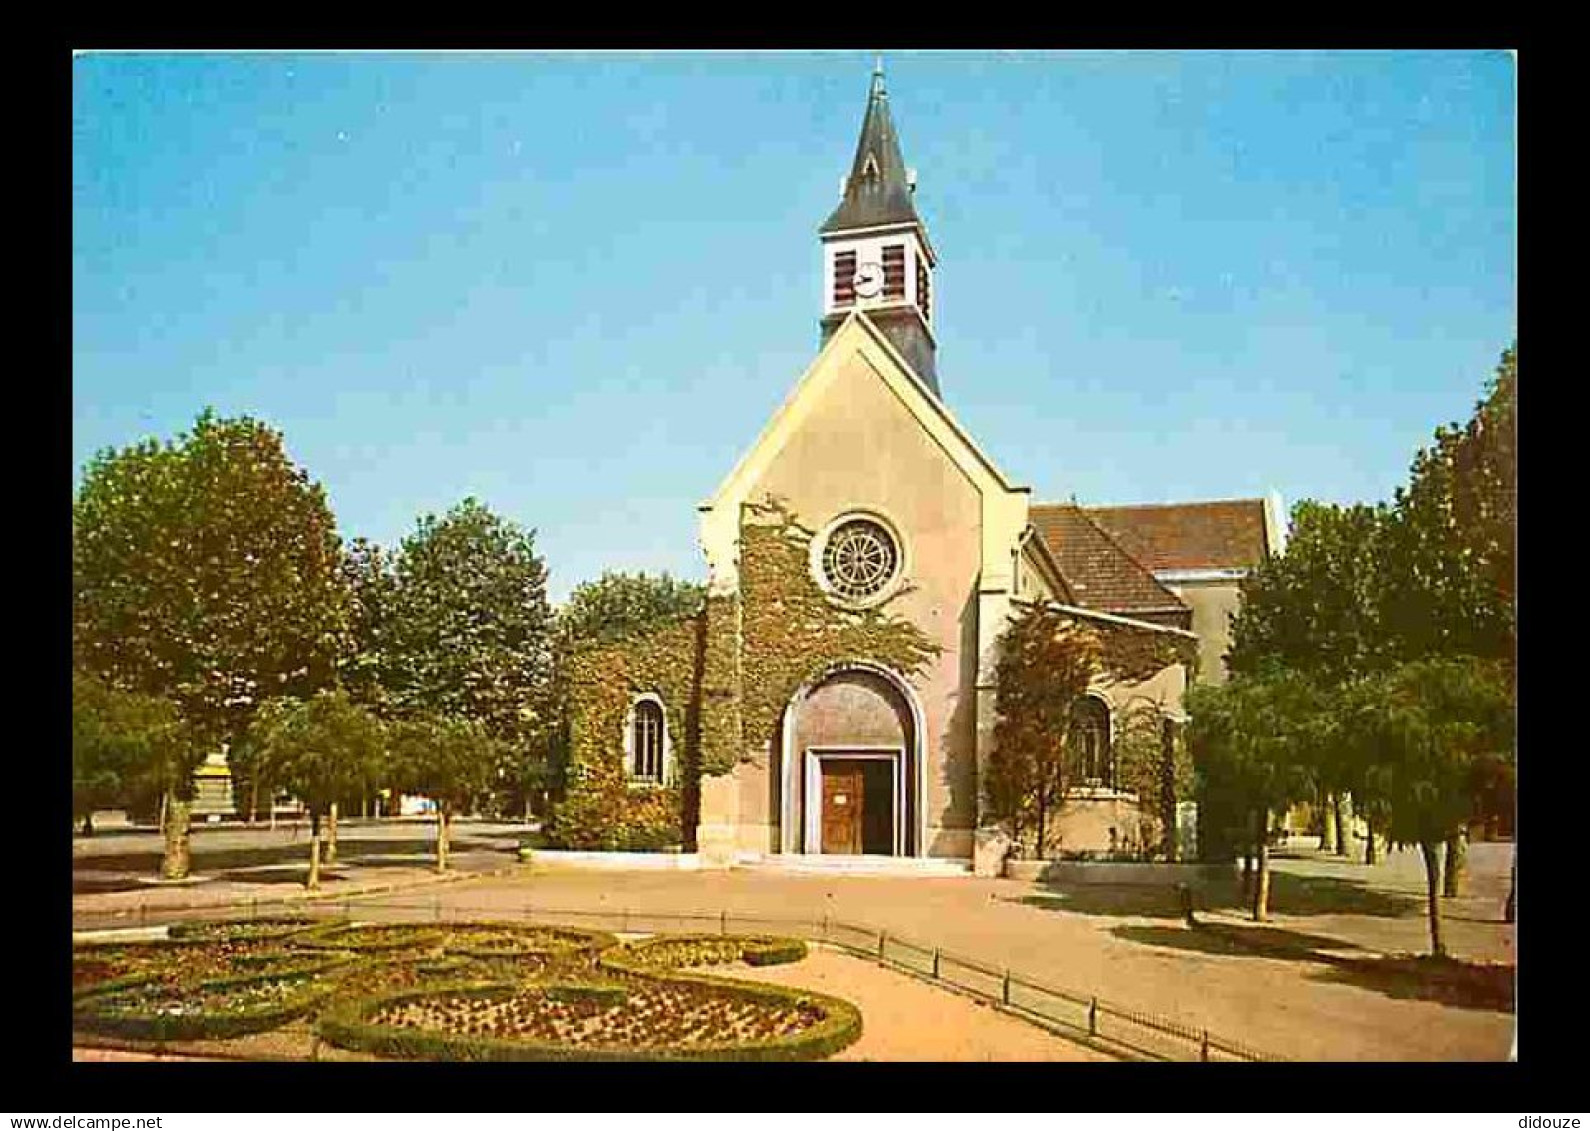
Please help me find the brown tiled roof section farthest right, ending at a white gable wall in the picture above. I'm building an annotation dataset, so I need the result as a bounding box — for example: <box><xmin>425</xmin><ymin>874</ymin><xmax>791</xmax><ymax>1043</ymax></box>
<box><xmin>1088</xmin><ymin>499</ymin><xmax>1266</xmax><ymax>571</ymax></box>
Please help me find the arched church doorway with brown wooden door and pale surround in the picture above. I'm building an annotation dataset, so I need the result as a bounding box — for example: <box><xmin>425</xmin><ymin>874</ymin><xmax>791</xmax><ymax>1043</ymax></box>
<box><xmin>779</xmin><ymin>663</ymin><xmax>924</xmax><ymax>856</ymax></box>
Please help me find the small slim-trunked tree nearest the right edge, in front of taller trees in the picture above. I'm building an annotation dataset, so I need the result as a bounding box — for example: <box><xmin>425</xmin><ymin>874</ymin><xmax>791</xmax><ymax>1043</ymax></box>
<box><xmin>1344</xmin><ymin>657</ymin><xmax>1514</xmax><ymax>956</ymax></box>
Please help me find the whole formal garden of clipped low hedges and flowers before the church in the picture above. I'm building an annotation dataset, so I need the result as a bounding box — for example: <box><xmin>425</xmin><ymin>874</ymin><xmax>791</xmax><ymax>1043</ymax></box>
<box><xmin>73</xmin><ymin>919</ymin><xmax>862</xmax><ymax>1059</ymax></box>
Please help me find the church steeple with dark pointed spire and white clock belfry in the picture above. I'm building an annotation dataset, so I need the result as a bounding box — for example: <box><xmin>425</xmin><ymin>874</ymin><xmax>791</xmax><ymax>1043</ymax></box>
<box><xmin>817</xmin><ymin>60</ymin><xmax>938</xmax><ymax>394</ymax></box>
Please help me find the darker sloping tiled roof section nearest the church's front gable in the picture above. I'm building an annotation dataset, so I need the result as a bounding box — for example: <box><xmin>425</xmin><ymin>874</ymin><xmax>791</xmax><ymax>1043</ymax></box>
<box><xmin>1029</xmin><ymin>503</ymin><xmax>1191</xmax><ymax>628</ymax></box>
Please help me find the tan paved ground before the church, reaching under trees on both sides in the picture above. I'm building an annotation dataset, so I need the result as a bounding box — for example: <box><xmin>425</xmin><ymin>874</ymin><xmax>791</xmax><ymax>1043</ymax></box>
<box><xmin>73</xmin><ymin>826</ymin><xmax>1514</xmax><ymax>1059</ymax></box>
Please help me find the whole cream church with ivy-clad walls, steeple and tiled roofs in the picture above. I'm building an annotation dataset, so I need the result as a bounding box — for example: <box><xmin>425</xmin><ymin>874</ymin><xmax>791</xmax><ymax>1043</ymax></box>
<box><xmin>552</xmin><ymin>68</ymin><xmax>1280</xmax><ymax>872</ymax></box>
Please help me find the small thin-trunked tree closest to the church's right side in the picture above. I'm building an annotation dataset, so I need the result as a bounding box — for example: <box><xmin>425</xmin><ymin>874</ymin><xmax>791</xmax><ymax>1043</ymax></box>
<box><xmin>1186</xmin><ymin>670</ymin><xmax>1328</xmax><ymax>923</ymax></box>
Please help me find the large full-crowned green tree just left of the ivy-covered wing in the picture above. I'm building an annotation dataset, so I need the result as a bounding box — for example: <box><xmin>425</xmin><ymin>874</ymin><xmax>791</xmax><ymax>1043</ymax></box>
<box><xmin>377</xmin><ymin>498</ymin><xmax>553</xmax><ymax>808</ymax></box>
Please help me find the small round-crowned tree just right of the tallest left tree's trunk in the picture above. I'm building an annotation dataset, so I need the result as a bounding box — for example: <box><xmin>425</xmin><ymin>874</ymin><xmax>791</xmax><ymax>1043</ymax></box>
<box><xmin>251</xmin><ymin>690</ymin><xmax>386</xmax><ymax>891</ymax></box>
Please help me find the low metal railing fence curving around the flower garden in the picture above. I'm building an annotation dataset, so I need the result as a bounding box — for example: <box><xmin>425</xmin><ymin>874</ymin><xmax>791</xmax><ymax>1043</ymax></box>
<box><xmin>73</xmin><ymin>894</ymin><xmax>1283</xmax><ymax>1061</ymax></box>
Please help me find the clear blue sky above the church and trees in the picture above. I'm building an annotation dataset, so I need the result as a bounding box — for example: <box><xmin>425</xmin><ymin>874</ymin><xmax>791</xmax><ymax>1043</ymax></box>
<box><xmin>72</xmin><ymin>51</ymin><xmax>1517</xmax><ymax>598</ymax></box>
